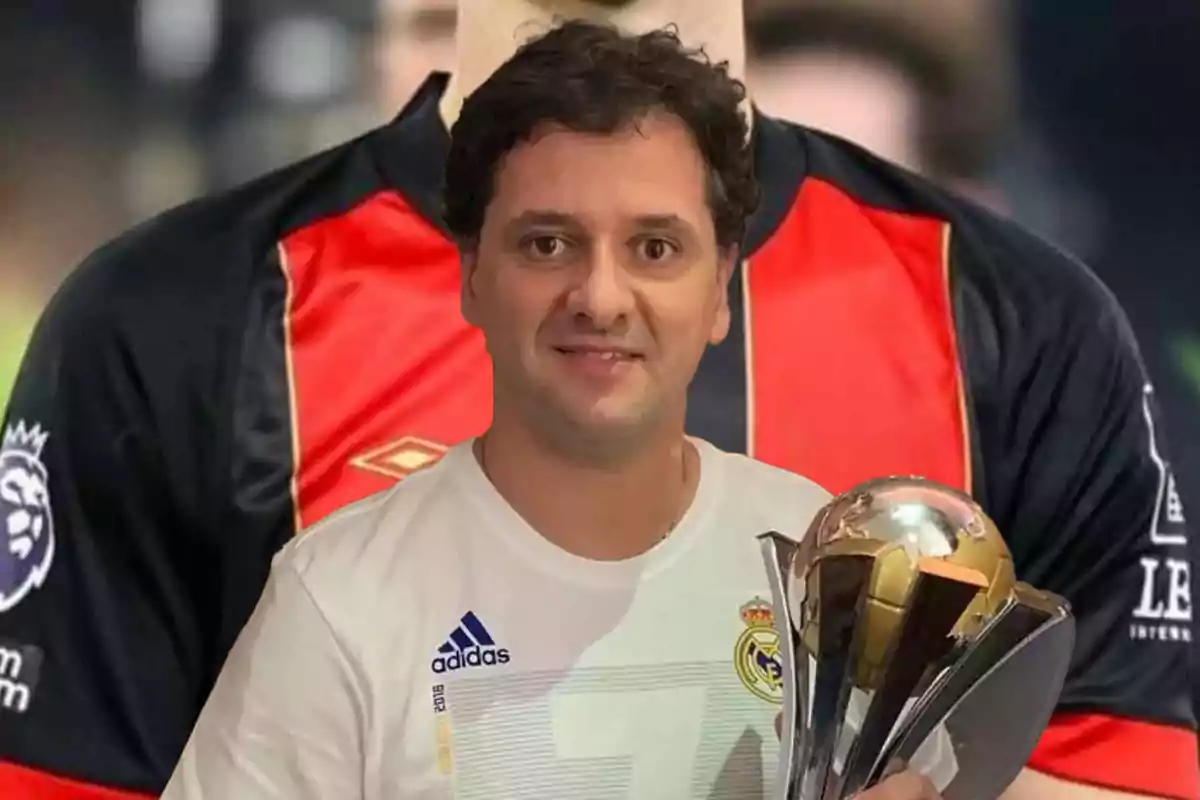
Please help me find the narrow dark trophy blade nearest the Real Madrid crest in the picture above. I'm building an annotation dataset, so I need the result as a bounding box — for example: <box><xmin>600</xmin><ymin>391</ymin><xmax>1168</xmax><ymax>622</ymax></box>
<box><xmin>798</xmin><ymin>555</ymin><xmax>875</xmax><ymax>800</ymax></box>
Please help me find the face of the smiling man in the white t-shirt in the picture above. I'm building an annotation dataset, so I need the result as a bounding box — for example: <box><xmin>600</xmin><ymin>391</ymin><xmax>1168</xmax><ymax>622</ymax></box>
<box><xmin>463</xmin><ymin>115</ymin><xmax>733</xmax><ymax>444</ymax></box>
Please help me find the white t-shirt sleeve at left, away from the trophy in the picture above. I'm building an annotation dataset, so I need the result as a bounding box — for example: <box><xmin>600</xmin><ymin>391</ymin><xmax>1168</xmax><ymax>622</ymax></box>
<box><xmin>162</xmin><ymin>552</ymin><xmax>365</xmax><ymax>800</ymax></box>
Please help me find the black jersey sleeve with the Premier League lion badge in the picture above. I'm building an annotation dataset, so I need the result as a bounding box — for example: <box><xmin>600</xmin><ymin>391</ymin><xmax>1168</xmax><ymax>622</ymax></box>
<box><xmin>0</xmin><ymin>235</ymin><xmax>229</xmax><ymax>800</ymax></box>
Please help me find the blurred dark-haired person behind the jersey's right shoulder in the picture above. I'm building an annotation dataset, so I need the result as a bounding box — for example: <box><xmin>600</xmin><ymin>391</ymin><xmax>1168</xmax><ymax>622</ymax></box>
<box><xmin>745</xmin><ymin>0</ymin><xmax>1012</xmax><ymax>205</ymax></box>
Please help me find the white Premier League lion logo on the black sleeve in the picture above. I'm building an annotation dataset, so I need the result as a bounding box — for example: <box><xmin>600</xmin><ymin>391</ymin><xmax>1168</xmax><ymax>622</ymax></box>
<box><xmin>0</xmin><ymin>421</ymin><xmax>54</xmax><ymax>613</ymax></box>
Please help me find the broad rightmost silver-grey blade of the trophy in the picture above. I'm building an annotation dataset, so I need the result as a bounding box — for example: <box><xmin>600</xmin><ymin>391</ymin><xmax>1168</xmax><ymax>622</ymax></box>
<box><xmin>870</xmin><ymin>601</ymin><xmax>1074</xmax><ymax>800</ymax></box>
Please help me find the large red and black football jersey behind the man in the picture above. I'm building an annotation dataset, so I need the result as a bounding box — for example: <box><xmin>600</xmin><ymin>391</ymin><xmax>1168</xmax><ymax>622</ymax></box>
<box><xmin>0</xmin><ymin>76</ymin><xmax>1200</xmax><ymax>800</ymax></box>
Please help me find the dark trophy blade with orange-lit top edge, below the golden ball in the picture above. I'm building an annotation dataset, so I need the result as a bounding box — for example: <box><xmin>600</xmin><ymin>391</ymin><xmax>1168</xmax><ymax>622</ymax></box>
<box><xmin>827</xmin><ymin>559</ymin><xmax>986</xmax><ymax>800</ymax></box>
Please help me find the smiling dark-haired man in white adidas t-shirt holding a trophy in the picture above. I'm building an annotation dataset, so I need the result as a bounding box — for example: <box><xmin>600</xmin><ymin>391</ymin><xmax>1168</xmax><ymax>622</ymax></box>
<box><xmin>163</xmin><ymin>23</ymin><xmax>936</xmax><ymax>800</ymax></box>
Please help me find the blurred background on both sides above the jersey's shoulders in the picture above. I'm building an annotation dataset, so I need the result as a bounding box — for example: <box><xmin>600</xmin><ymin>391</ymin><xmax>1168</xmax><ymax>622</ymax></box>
<box><xmin>0</xmin><ymin>0</ymin><xmax>1200</xmax><ymax>546</ymax></box>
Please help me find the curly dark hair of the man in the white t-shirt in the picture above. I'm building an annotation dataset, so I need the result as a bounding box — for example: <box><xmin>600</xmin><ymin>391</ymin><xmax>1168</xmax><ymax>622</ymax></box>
<box><xmin>443</xmin><ymin>20</ymin><xmax>758</xmax><ymax>248</ymax></box>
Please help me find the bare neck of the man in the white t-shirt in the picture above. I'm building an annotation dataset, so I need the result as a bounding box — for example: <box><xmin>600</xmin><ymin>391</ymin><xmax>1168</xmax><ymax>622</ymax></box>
<box><xmin>475</xmin><ymin>419</ymin><xmax>700</xmax><ymax>561</ymax></box>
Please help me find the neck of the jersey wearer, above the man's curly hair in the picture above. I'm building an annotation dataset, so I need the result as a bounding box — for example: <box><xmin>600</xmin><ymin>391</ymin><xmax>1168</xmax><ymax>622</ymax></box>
<box><xmin>440</xmin><ymin>0</ymin><xmax>749</xmax><ymax>127</ymax></box>
